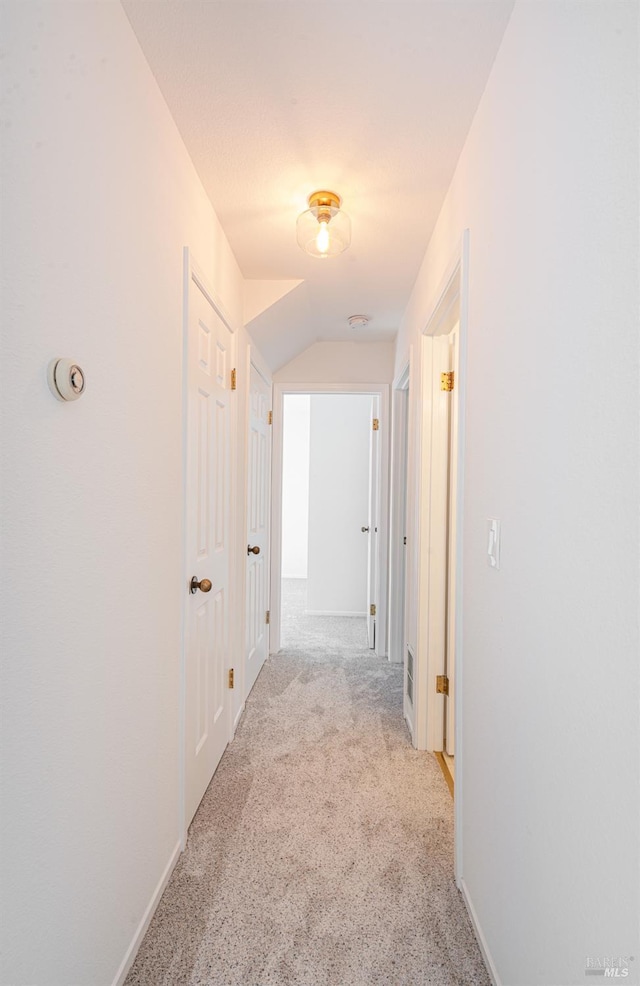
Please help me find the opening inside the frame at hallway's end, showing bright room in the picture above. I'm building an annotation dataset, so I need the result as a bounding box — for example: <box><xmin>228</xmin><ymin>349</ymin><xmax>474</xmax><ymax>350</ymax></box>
<box><xmin>281</xmin><ymin>393</ymin><xmax>379</xmax><ymax>649</ymax></box>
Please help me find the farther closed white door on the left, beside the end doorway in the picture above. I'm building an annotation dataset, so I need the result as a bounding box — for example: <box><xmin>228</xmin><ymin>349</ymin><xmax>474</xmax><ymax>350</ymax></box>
<box><xmin>245</xmin><ymin>365</ymin><xmax>271</xmax><ymax>695</ymax></box>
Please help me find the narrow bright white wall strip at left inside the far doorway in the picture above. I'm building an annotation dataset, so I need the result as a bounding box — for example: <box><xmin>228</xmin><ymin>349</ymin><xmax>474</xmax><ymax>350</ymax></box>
<box><xmin>282</xmin><ymin>394</ymin><xmax>311</xmax><ymax>579</ymax></box>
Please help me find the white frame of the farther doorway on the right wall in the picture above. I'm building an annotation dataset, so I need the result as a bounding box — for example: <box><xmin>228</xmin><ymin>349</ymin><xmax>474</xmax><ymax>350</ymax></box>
<box><xmin>389</xmin><ymin>361</ymin><xmax>409</xmax><ymax>664</ymax></box>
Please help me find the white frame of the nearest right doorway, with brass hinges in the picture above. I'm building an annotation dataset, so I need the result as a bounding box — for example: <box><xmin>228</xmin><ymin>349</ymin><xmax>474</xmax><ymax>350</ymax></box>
<box><xmin>412</xmin><ymin>230</ymin><xmax>469</xmax><ymax>886</ymax></box>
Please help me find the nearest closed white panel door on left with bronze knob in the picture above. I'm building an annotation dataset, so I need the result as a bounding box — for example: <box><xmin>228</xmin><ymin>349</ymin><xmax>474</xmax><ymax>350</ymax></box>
<box><xmin>185</xmin><ymin>264</ymin><xmax>233</xmax><ymax>830</ymax></box>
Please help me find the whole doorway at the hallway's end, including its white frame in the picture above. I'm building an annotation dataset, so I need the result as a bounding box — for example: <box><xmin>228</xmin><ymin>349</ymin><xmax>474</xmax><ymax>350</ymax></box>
<box><xmin>270</xmin><ymin>383</ymin><xmax>389</xmax><ymax>657</ymax></box>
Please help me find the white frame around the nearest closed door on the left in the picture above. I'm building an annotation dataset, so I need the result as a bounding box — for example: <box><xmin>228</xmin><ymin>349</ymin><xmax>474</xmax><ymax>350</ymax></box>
<box><xmin>178</xmin><ymin>247</ymin><xmax>240</xmax><ymax>850</ymax></box>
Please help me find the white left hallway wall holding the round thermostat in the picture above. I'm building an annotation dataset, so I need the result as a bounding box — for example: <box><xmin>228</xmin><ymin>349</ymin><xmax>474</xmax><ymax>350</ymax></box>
<box><xmin>0</xmin><ymin>2</ymin><xmax>242</xmax><ymax>986</ymax></box>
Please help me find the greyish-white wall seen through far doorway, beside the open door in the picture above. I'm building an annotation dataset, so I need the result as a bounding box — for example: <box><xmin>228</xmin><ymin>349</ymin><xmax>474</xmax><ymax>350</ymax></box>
<box><xmin>307</xmin><ymin>394</ymin><xmax>373</xmax><ymax>616</ymax></box>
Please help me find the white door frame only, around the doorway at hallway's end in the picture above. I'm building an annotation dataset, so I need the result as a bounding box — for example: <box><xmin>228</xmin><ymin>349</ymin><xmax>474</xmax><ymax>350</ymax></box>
<box><xmin>270</xmin><ymin>381</ymin><xmax>390</xmax><ymax>657</ymax></box>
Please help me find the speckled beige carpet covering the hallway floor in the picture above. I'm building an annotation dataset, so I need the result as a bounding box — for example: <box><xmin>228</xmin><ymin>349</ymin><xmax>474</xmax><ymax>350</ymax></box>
<box><xmin>126</xmin><ymin>581</ymin><xmax>490</xmax><ymax>986</ymax></box>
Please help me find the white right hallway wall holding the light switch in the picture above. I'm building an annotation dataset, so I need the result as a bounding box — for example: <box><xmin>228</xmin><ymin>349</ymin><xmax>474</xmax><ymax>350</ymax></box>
<box><xmin>397</xmin><ymin>0</ymin><xmax>640</xmax><ymax>986</ymax></box>
